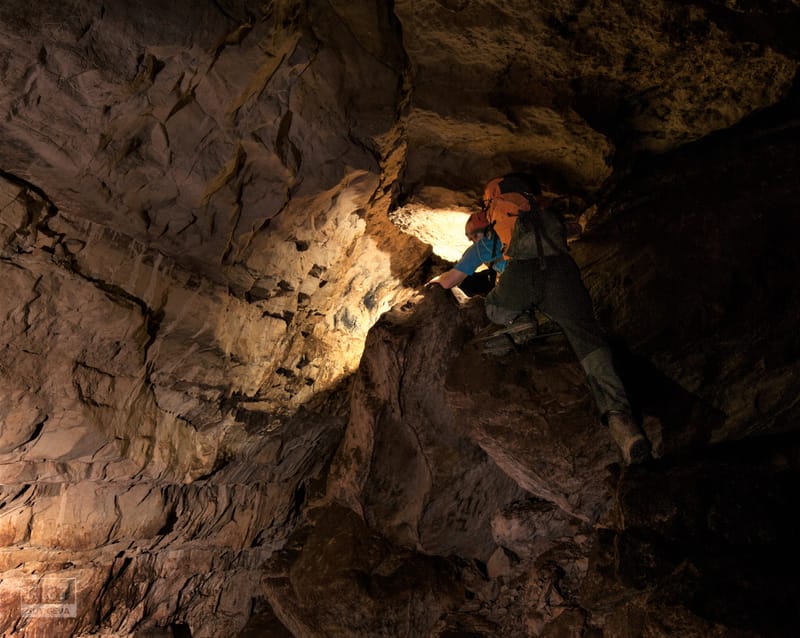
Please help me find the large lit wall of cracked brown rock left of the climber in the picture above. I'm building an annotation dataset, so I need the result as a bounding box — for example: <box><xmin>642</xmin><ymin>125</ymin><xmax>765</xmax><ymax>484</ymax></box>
<box><xmin>0</xmin><ymin>2</ymin><xmax>430</xmax><ymax>635</ymax></box>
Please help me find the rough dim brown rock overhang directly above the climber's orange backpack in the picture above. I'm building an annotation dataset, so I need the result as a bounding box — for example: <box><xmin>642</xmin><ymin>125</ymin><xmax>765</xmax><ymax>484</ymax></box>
<box><xmin>395</xmin><ymin>0</ymin><xmax>797</xmax><ymax>199</ymax></box>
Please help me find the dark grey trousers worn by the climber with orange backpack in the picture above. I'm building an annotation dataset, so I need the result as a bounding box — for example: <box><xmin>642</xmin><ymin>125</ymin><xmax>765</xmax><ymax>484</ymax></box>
<box><xmin>486</xmin><ymin>255</ymin><xmax>630</xmax><ymax>420</ymax></box>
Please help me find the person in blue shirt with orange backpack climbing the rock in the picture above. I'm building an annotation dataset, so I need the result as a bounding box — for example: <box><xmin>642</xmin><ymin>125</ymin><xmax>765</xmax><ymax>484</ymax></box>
<box><xmin>428</xmin><ymin>173</ymin><xmax>651</xmax><ymax>465</ymax></box>
